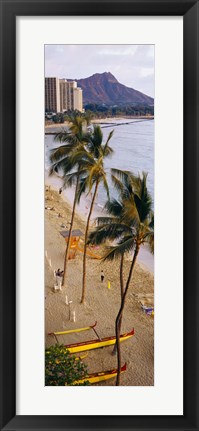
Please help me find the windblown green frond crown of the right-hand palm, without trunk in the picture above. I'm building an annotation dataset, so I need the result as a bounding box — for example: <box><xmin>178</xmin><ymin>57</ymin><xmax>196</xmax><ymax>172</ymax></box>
<box><xmin>87</xmin><ymin>169</ymin><xmax>154</xmax><ymax>260</ymax></box>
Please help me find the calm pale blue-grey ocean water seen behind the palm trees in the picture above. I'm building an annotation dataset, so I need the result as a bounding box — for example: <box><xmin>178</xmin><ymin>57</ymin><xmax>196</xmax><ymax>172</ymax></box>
<box><xmin>45</xmin><ymin>119</ymin><xmax>154</xmax><ymax>271</ymax></box>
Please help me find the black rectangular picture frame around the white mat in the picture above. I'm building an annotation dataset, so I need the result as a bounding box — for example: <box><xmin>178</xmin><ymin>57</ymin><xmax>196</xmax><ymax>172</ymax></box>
<box><xmin>0</xmin><ymin>0</ymin><xmax>199</xmax><ymax>431</ymax></box>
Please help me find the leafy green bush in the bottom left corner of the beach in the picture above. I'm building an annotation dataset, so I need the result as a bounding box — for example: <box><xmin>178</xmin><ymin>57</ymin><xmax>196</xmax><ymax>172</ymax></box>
<box><xmin>45</xmin><ymin>344</ymin><xmax>89</xmax><ymax>386</ymax></box>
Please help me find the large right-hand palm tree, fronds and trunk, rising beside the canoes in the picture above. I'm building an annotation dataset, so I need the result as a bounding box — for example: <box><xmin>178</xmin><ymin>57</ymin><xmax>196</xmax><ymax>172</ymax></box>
<box><xmin>89</xmin><ymin>169</ymin><xmax>154</xmax><ymax>386</ymax></box>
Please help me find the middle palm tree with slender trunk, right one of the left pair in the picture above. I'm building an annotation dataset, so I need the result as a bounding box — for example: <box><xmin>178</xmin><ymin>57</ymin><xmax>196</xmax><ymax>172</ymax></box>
<box><xmin>79</xmin><ymin>126</ymin><xmax>113</xmax><ymax>303</ymax></box>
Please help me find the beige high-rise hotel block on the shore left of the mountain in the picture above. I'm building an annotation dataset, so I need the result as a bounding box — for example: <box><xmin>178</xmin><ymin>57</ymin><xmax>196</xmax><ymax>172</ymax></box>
<box><xmin>45</xmin><ymin>78</ymin><xmax>83</xmax><ymax>112</ymax></box>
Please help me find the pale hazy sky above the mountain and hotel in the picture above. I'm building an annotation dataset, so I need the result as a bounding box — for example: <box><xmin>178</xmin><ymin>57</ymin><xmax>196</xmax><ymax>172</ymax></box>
<box><xmin>45</xmin><ymin>45</ymin><xmax>154</xmax><ymax>97</ymax></box>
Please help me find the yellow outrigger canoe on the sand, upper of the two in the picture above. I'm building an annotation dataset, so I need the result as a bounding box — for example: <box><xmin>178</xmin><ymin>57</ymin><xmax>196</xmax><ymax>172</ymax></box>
<box><xmin>65</xmin><ymin>328</ymin><xmax>134</xmax><ymax>353</ymax></box>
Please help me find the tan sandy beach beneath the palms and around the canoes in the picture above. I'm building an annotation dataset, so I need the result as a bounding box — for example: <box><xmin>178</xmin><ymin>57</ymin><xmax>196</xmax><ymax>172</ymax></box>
<box><xmin>45</xmin><ymin>186</ymin><xmax>154</xmax><ymax>386</ymax></box>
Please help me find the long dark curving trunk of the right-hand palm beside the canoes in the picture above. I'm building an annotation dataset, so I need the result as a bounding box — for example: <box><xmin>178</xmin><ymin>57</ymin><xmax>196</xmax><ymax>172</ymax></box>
<box><xmin>115</xmin><ymin>244</ymin><xmax>140</xmax><ymax>386</ymax></box>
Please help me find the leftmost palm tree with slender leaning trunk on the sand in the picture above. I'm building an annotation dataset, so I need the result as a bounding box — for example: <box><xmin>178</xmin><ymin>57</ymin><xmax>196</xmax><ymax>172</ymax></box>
<box><xmin>50</xmin><ymin>115</ymin><xmax>90</xmax><ymax>287</ymax></box>
